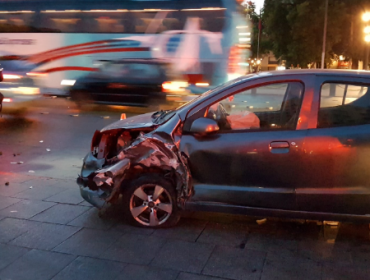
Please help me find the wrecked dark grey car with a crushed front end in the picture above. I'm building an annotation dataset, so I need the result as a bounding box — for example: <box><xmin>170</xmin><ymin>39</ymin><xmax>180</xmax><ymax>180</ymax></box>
<box><xmin>77</xmin><ymin>70</ymin><xmax>370</xmax><ymax>227</ymax></box>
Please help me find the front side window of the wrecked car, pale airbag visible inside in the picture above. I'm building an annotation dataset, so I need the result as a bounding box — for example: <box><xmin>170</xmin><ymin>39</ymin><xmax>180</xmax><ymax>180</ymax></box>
<box><xmin>206</xmin><ymin>82</ymin><xmax>303</xmax><ymax>131</ymax></box>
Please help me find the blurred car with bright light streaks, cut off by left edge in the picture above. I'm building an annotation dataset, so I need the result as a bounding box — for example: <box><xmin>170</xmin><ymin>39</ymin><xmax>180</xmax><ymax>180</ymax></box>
<box><xmin>0</xmin><ymin>55</ymin><xmax>45</xmax><ymax>107</ymax></box>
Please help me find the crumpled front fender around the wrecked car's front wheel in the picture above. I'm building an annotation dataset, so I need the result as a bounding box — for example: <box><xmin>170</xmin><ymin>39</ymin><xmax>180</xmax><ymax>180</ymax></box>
<box><xmin>82</xmin><ymin>132</ymin><xmax>192</xmax><ymax>206</ymax></box>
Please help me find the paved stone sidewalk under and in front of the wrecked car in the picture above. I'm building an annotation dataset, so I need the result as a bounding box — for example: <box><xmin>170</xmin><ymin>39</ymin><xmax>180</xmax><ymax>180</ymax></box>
<box><xmin>0</xmin><ymin>173</ymin><xmax>370</xmax><ymax>280</ymax></box>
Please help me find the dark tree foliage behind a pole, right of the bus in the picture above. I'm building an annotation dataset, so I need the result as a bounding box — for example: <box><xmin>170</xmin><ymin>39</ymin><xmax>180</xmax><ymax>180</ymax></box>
<box><xmin>262</xmin><ymin>0</ymin><xmax>370</xmax><ymax>66</ymax></box>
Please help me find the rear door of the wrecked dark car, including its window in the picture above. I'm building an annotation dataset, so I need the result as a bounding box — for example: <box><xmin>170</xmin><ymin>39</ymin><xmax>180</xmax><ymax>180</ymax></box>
<box><xmin>296</xmin><ymin>76</ymin><xmax>370</xmax><ymax>214</ymax></box>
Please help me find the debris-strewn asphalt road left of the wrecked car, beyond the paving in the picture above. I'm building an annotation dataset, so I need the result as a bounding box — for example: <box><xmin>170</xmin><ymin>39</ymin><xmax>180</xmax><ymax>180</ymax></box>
<box><xmin>0</xmin><ymin>98</ymin><xmax>147</xmax><ymax>179</ymax></box>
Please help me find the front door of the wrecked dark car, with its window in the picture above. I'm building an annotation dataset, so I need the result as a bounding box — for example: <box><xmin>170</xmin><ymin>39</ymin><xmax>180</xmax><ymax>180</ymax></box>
<box><xmin>180</xmin><ymin>74</ymin><xmax>312</xmax><ymax>209</ymax></box>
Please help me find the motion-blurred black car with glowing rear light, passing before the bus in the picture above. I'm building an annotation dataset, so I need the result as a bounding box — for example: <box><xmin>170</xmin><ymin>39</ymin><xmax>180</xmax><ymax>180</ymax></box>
<box><xmin>69</xmin><ymin>59</ymin><xmax>188</xmax><ymax>106</ymax></box>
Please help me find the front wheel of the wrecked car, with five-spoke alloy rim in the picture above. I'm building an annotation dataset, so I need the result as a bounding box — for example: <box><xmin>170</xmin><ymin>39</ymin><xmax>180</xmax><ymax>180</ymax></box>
<box><xmin>122</xmin><ymin>174</ymin><xmax>180</xmax><ymax>228</ymax></box>
